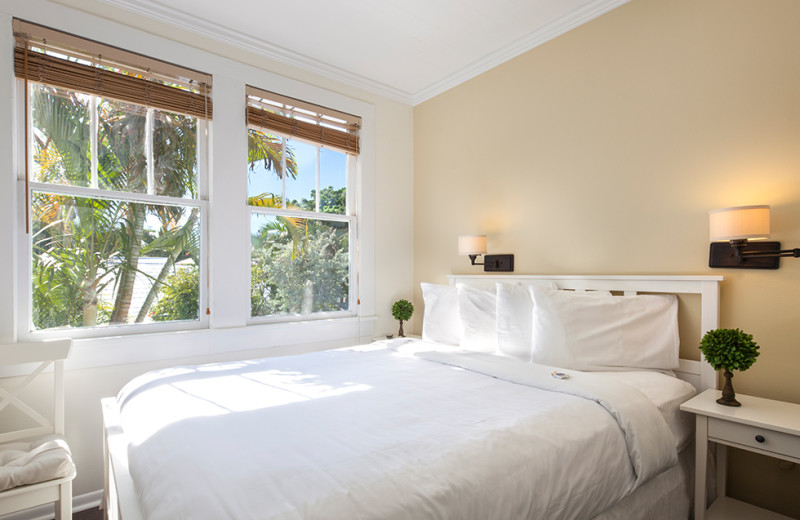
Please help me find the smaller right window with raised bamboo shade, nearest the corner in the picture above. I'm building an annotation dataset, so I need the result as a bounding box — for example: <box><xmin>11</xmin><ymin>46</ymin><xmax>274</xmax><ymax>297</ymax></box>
<box><xmin>247</xmin><ymin>87</ymin><xmax>360</xmax><ymax>321</ymax></box>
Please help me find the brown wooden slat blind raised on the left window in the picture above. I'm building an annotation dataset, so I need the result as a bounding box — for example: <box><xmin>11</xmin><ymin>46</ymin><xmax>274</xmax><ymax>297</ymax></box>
<box><xmin>14</xmin><ymin>20</ymin><xmax>213</xmax><ymax>119</ymax></box>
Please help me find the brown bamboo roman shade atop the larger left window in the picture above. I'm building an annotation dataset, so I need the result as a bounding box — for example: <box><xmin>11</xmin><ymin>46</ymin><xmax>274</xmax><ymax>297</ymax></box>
<box><xmin>14</xmin><ymin>19</ymin><xmax>213</xmax><ymax>119</ymax></box>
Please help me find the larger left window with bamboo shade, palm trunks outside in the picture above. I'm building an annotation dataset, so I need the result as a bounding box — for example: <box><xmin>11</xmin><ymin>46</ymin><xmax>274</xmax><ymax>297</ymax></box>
<box><xmin>14</xmin><ymin>20</ymin><xmax>211</xmax><ymax>335</ymax></box>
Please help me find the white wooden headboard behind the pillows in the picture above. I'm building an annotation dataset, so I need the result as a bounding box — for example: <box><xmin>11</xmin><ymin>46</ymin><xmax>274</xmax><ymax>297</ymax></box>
<box><xmin>448</xmin><ymin>274</ymin><xmax>722</xmax><ymax>391</ymax></box>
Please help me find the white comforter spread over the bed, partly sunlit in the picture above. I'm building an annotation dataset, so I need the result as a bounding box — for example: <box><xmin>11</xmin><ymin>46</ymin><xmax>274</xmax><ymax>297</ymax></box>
<box><xmin>119</xmin><ymin>344</ymin><xmax>676</xmax><ymax>520</ymax></box>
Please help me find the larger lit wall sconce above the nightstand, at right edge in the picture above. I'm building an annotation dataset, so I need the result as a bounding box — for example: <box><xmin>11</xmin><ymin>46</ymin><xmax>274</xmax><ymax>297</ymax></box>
<box><xmin>708</xmin><ymin>206</ymin><xmax>800</xmax><ymax>269</ymax></box>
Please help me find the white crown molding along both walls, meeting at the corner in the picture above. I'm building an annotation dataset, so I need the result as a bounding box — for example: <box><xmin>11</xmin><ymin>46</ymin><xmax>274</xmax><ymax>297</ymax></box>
<box><xmin>101</xmin><ymin>0</ymin><xmax>630</xmax><ymax>106</ymax></box>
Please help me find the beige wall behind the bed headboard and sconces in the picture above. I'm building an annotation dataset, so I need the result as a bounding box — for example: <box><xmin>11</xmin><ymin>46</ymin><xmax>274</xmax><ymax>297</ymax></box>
<box><xmin>414</xmin><ymin>0</ymin><xmax>800</xmax><ymax>517</ymax></box>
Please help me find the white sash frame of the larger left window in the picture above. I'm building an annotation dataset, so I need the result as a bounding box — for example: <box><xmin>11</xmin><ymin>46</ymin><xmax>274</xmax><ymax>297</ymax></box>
<box><xmin>14</xmin><ymin>78</ymin><xmax>210</xmax><ymax>341</ymax></box>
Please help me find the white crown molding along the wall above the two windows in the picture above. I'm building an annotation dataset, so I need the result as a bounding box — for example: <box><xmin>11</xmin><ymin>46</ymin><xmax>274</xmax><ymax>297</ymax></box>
<box><xmin>101</xmin><ymin>0</ymin><xmax>412</xmax><ymax>105</ymax></box>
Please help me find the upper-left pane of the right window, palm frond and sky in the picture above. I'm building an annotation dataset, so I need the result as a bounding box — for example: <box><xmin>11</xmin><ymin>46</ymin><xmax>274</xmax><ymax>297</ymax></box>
<box><xmin>247</xmin><ymin>128</ymin><xmax>290</xmax><ymax>208</ymax></box>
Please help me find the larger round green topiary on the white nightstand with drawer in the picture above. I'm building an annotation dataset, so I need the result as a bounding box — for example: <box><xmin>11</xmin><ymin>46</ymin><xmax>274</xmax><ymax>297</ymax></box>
<box><xmin>700</xmin><ymin>329</ymin><xmax>759</xmax><ymax>406</ymax></box>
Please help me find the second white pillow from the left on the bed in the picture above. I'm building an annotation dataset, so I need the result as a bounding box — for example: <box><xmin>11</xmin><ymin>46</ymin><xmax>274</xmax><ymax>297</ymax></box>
<box><xmin>456</xmin><ymin>283</ymin><xmax>497</xmax><ymax>353</ymax></box>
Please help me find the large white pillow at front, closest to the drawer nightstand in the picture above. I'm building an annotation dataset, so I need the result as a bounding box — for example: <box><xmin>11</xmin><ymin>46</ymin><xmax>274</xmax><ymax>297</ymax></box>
<box><xmin>531</xmin><ymin>287</ymin><xmax>679</xmax><ymax>370</ymax></box>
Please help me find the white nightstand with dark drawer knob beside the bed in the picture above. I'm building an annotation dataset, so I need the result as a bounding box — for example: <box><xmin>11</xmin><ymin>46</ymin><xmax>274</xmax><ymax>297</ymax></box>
<box><xmin>681</xmin><ymin>390</ymin><xmax>800</xmax><ymax>520</ymax></box>
